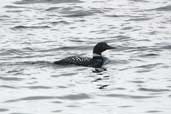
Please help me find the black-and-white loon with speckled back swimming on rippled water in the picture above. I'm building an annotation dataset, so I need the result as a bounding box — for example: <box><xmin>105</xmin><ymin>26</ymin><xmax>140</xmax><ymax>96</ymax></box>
<box><xmin>54</xmin><ymin>42</ymin><xmax>115</xmax><ymax>68</ymax></box>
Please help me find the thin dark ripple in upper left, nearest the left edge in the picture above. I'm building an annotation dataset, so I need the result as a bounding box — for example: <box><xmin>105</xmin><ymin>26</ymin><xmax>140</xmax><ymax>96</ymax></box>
<box><xmin>11</xmin><ymin>25</ymin><xmax>50</xmax><ymax>30</ymax></box>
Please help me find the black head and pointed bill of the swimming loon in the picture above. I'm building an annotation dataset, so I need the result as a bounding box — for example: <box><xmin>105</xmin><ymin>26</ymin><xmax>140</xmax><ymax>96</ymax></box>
<box><xmin>93</xmin><ymin>42</ymin><xmax>115</xmax><ymax>55</ymax></box>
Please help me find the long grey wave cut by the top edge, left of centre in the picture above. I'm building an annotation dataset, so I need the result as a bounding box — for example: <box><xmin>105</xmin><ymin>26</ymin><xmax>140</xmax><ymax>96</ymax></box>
<box><xmin>15</xmin><ymin>0</ymin><xmax>82</xmax><ymax>4</ymax></box>
